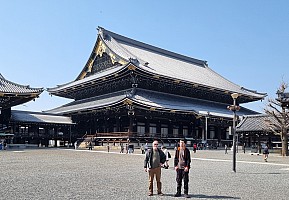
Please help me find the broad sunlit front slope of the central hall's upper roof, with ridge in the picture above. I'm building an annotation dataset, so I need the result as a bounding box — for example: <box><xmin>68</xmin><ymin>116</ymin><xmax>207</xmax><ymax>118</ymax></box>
<box><xmin>99</xmin><ymin>27</ymin><xmax>266</xmax><ymax>99</ymax></box>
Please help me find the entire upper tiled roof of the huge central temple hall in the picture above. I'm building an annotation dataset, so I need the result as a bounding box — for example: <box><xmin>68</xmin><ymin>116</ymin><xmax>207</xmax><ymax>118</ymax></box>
<box><xmin>48</xmin><ymin>27</ymin><xmax>267</xmax><ymax>102</ymax></box>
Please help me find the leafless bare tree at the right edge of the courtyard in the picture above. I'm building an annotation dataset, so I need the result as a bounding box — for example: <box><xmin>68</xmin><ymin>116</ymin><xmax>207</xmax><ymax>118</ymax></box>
<box><xmin>264</xmin><ymin>81</ymin><xmax>289</xmax><ymax>156</ymax></box>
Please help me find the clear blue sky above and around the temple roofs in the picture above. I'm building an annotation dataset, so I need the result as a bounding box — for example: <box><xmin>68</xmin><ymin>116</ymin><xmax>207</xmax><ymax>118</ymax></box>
<box><xmin>0</xmin><ymin>0</ymin><xmax>289</xmax><ymax>112</ymax></box>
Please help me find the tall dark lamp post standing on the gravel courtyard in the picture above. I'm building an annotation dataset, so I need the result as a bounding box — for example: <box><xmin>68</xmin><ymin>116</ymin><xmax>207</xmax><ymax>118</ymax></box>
<box><xmin>227</xmin><ymin>93</ymin><xmax>240</xmax><ymax>172</ymax></box>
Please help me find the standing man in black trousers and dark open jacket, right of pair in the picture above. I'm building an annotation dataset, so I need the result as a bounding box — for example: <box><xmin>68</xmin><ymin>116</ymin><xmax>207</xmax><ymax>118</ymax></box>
<box><xmin>174</xmin><ymin>140</ymin><xmax>191</xmax><ymax>198</ymax></box>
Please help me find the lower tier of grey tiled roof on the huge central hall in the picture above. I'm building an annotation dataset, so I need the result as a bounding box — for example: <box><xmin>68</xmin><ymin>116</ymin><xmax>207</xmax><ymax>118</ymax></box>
<box><xmin>47</xmin><ymin>89</ymin><xmax>256</xmax><ymax>117</ymax></box>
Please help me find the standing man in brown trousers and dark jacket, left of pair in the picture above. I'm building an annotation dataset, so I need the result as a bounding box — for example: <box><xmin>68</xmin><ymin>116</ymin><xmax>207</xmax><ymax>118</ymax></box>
<box><xmin>144</xmin><ymin>140</ymin><xmax>166</xmax><ymax>196</ymax></box>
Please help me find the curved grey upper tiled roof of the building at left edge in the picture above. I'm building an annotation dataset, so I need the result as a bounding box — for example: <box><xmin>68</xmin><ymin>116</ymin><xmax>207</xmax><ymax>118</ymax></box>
<box><xmin>0</xmin><ymin>74</ymin><xmax>43</xmax><ymax>94</ymax></box>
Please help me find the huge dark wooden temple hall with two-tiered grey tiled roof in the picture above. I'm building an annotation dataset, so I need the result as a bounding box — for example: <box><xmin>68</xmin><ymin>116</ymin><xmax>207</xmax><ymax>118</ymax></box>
<box><xmin>47</xmin><ymin>27</ymin><xmax>266</xmax><ymax>148</ymax></box>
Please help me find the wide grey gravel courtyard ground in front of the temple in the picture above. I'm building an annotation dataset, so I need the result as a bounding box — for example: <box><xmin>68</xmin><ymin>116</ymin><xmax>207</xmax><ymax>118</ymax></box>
<box><xmin>0</xmin><ymin>149</ymin><xmax>289</xmax><ymax>200</ymax></box>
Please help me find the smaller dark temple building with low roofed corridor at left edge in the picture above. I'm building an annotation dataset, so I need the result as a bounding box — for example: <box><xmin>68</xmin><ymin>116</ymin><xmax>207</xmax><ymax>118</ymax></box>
<box><xmin>0</xmin><ymin>74</ymin><xmax>74</xmax><ymax>147</ymax></box>
